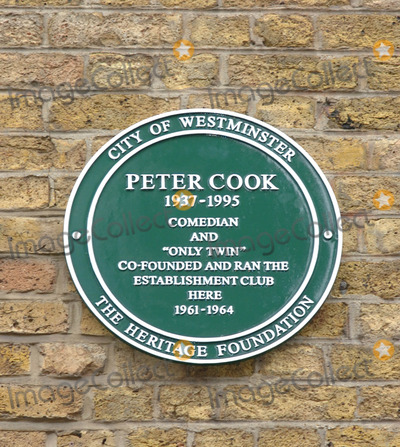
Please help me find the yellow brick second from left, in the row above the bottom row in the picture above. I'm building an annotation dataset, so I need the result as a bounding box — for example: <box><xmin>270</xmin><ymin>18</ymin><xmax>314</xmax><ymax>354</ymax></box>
<box><xmin>94</xmin><ymin>386</ymin><xmax>153</xmax><ymax>421</ymax></box>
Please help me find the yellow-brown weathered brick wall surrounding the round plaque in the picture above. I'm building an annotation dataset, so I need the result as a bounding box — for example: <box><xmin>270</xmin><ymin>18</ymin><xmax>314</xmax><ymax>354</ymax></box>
<box><xmin>0</xmin><ymin>0</ymin><xmax>400</xmax><ymax>447</ymax></box>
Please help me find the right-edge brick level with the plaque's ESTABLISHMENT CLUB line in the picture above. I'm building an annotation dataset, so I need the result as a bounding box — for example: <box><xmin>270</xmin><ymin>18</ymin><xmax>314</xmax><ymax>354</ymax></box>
<box><xmin>332</xmin><ymin>261</ymin><xmax>400</xmax><ymax>299</ymax></box>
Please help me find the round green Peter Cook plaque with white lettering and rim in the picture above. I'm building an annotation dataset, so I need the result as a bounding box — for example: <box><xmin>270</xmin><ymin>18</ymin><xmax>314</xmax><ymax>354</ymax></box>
<box><xmin>64</xmin><ymin>109</ymin><xmax>342</xmax><ymax>364</ymax></box>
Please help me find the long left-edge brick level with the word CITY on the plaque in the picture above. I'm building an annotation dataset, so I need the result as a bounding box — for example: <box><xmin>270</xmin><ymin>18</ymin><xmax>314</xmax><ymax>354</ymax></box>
<box><xmin>0</xmin><ymin>136</ymin><xmax>86</xmax><ymax>171</ymax></box>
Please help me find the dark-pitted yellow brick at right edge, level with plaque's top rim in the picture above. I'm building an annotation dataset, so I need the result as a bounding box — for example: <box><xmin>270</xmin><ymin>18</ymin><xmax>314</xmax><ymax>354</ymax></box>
<box><xmin>325</xmin><ymin>97</ymin><xmax>400</xmax><ymax>130</ymax></box>
